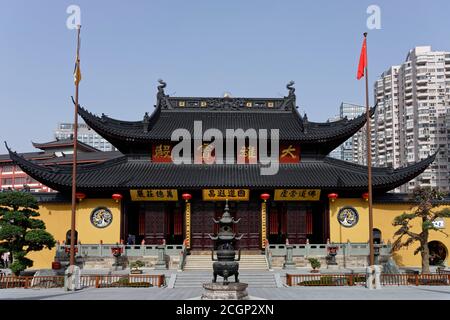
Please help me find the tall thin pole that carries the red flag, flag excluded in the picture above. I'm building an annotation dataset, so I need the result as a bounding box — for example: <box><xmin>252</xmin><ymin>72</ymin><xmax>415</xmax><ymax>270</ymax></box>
<box><xmin>364</xmin><ymin>32</ymin><xmax>375</xmax><ymax>266</ymax></box>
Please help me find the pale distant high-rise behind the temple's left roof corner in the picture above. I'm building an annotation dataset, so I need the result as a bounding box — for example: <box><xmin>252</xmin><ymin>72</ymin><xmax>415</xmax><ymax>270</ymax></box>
<box><xmin>55</xmin><ymin>123</ymin><xmax>116</xmax><ymax>151</ymax></box>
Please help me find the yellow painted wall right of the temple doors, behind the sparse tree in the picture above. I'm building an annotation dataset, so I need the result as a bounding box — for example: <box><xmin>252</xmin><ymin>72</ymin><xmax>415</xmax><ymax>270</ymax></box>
<box><xmin>330</xmin><ymin>199</ymin><xmax>450</xmax><ymax>267</ymax></box>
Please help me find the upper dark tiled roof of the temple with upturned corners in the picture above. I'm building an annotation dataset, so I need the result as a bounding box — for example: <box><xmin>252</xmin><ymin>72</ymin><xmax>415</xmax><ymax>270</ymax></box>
<box><xmin>78</xmin><ymin>98</ymin><xmax>375</xmax><ymax>154</ymax></box>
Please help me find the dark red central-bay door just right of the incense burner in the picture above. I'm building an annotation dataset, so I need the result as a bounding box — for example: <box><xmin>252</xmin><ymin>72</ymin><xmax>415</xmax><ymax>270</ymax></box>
<box><xmin>234</xmin><ymin>202</ymin><xmax>261</xmax><ymax>250</ymax></box>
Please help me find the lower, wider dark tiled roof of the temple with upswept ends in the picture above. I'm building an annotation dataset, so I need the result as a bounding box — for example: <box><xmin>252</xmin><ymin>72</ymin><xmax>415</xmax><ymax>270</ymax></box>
<box><xmin>8</xmin><ymin>149</ymin><xmax>436</xmax><ymax>192</ymax></box>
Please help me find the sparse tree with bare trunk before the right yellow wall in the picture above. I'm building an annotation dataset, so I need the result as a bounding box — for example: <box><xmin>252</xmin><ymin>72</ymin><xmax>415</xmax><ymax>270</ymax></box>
<box><xmin>392</xmin><ymin>187</ymin><xmax>450</xmax><ymax>273</ymax></box>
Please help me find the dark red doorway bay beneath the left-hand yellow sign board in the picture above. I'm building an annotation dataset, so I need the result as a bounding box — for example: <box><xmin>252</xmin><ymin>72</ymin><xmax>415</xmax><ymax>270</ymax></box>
<box><xmin>123</xmin><ymin>202</ymin><xmax>184</xmax><ymax>244</ymax></box>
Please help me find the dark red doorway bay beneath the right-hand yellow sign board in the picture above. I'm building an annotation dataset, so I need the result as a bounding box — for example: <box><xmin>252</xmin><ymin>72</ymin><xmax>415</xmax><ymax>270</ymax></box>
<box><xmin>267</xmin><ymin>201</ymin><xmax>327</xmax><ymax>244</ymax></box>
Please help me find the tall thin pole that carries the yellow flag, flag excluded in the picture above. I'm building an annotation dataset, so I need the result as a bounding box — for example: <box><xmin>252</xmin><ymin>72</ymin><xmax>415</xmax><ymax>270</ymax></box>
<box><xmin>70</xmin><ymin>25</ymin><xmax>81</xmax><ymax>266</ymax></box>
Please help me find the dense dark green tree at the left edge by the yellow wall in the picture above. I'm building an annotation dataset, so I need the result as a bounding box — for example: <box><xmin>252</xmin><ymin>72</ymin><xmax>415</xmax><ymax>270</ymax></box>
<box><xmin>0</xmin><ymin>191</ymin><xmax>55</xmax><ymax>275</ymax></box>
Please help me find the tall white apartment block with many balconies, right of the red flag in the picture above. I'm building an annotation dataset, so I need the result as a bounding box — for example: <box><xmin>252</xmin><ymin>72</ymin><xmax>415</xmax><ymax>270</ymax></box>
<box><xmin>372</xmin><ymin>46</ymin><xmax>450</xmax><ymax>192</ymax></box>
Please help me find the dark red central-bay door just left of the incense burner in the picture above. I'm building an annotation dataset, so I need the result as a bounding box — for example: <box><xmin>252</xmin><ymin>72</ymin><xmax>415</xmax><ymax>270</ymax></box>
<box><xmin>191</xmin><ymin>202</ymin><xmax>215</xmax><ymax>250</ymax></box>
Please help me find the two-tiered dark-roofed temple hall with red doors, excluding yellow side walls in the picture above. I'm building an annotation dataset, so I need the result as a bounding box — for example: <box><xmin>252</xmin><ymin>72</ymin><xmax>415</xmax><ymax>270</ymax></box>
<box><xmin>10</xmin><ymin>85</ymin><xmax>434</xmax><ymax>250</ymax></box>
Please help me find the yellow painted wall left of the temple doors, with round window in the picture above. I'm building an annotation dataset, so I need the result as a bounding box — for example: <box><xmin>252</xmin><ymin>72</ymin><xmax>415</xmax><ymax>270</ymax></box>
<box><xmin>27</xmin><ymin>199</ymin><xmax>120</xmax><ymax>269</ymax></box>
